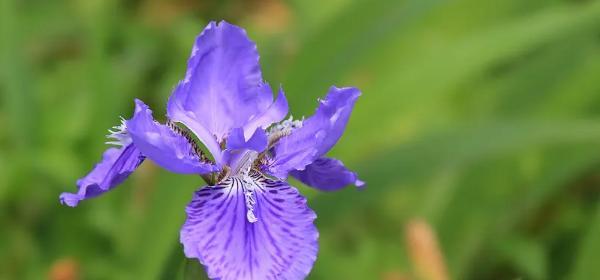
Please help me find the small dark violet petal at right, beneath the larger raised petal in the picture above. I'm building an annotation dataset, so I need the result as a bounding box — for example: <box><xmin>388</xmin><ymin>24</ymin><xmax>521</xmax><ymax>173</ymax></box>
<box><xmin>290</xmin><ymin>158</ymin><xmax>365</xmax><ymax>191</ymax></box>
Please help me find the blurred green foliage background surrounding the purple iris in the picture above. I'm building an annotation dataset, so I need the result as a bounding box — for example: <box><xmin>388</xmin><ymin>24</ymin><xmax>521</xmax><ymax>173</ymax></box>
<box><xmin>0</xmin><ymin>0</ymin><xmax>600</xmax><ymax>280</ymax></box>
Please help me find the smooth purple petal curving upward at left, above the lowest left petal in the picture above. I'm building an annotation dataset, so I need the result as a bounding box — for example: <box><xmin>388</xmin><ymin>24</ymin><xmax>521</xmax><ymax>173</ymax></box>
<box><xmin>127</xmin><ymin>99</ymin><xmax>218</xmax><ymax>174</ymax></box>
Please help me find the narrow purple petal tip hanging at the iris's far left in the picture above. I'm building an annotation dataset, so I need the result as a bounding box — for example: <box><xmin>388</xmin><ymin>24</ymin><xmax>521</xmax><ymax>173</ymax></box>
<box><xmin>60</xmin><ymin>144</ymin><xmax>144</xmax><ymax>207</ymax></box>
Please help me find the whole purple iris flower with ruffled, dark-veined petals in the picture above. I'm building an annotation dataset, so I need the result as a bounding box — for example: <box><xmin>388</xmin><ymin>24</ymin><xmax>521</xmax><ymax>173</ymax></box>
<box><xmin>60</xmin><ymin>22</ymin><xmax>364</xmax><ymax>279</ymax></box>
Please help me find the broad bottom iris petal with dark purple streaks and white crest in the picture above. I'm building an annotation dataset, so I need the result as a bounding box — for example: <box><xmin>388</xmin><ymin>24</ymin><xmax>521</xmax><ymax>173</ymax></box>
<box><xmin>181</xmin><ymin>173</ymin><xmax>318</xmax><ymax>280</ymax></box>
